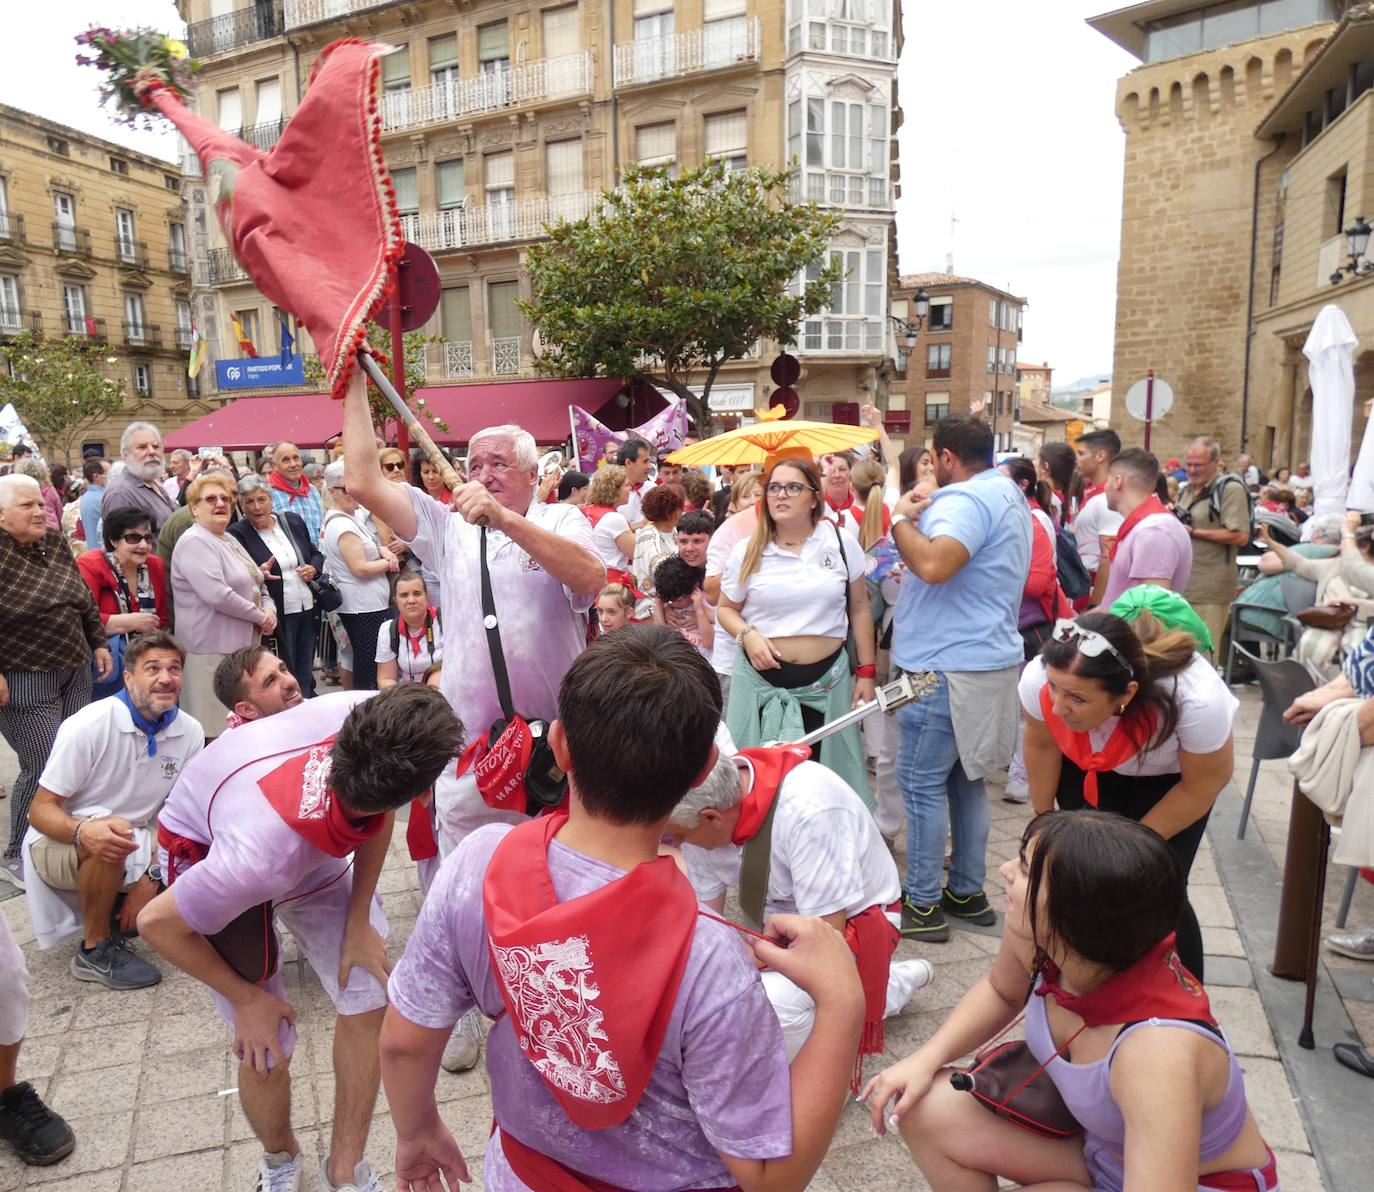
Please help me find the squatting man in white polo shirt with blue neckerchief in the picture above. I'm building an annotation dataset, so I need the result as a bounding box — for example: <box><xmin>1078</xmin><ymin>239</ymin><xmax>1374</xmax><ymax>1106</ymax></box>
<box><xmin>23</xmin><ymin>632</ymin><xmax>205</xmax><ymax>990</ymax></box>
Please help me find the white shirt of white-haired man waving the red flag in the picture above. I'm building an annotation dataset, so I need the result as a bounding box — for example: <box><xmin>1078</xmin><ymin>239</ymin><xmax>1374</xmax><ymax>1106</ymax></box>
<box><xmin>392</xmin><ymin>486</ymin><xmax>605</xmax><ymax>739</ymax></box>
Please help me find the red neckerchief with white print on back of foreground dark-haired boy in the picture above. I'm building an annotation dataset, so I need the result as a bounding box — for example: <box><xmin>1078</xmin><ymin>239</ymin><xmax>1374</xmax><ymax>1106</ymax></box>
<box><xmin>482</xmin><ymin>813</ymin><xmax>697</xmax><ymax>1130</ymax></box>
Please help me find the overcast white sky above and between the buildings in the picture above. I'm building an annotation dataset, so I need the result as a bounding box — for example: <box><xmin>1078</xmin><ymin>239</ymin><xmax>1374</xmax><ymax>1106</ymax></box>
<box><xmin>0</xmin><ymin>0</ymin><xmax>1135</xmax><ymax>385</ymax></box>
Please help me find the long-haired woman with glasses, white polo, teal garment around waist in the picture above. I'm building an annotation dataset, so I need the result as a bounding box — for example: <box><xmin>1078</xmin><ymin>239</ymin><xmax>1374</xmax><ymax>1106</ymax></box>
<box><xmin>716</xmin><ymin>459</ymin><xmax>875</xmax><ymax>806</ymax></box>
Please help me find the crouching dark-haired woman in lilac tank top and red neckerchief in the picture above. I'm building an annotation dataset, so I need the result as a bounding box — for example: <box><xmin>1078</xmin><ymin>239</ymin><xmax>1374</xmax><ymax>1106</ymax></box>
<box><xmin>863</xmin><ymin>813</ymin><xmax>1278</xmax><ymax>1192</ymax></box>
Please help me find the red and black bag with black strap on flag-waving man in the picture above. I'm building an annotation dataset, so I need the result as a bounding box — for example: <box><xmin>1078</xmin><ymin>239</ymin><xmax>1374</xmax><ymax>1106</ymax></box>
<box><xmin>474</xmin><ymin>526</ymin><xmax>567</xmax><ymax>816</ymax></box>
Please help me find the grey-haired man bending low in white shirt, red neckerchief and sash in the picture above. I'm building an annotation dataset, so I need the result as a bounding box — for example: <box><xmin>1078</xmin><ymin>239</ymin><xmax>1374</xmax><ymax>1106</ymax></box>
<box><xmin>668</xmin><ymin>746</ymin><xmax>933</xmax><ymax>1071</ymax></box>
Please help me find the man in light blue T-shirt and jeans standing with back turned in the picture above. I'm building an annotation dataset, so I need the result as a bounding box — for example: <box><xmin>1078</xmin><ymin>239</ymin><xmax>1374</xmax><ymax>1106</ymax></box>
<box><xmin>892</xmin><ymin>416</ymin><xmax>1031</xmax><ymax>942</ymax></box>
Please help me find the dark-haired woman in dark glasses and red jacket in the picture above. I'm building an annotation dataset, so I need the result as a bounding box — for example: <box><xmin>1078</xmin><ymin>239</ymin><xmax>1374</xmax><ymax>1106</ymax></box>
<box><xmin>77</xmin><ymin>508</ymin><xmax>169</xmax><ymax>699</ymax></box>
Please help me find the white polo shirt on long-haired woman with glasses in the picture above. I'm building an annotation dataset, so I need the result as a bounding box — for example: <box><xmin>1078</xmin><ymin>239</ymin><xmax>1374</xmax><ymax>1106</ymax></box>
<box><xmin>720</xmin><ymin>518</ymin><xmax>864</xmax><ymax>639</ymax></box>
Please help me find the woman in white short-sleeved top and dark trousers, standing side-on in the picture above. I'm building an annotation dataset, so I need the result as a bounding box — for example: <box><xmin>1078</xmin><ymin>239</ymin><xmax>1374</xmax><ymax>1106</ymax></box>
<box><xmin>320</xmin><ymin>460</ymin><xmax>404</xmax><ymax>691</ymax></box>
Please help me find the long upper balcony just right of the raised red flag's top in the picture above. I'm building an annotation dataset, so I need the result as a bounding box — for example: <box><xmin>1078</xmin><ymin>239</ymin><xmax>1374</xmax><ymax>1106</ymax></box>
<box><xmin>382</xmin><ymin>51</ymin><xmax>592</xmax><ymax>132</ymax></box>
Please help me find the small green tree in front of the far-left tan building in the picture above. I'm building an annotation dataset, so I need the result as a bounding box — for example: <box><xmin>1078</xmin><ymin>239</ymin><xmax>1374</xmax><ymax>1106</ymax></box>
<box><xmin>0</xmin><ymin>331</ymin><xmax>124</xmax><ymax>464</ymax></box>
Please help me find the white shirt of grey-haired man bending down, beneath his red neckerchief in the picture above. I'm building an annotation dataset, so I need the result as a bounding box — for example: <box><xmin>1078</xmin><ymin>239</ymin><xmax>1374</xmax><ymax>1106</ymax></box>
<box><xmin>682</xmin><ymin>758</ymin><xmax>901</xmax><ymax>919</ymax></box>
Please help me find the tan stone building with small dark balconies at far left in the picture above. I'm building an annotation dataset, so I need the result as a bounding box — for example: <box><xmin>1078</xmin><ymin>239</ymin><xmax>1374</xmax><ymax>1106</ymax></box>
<box><xmin>0</xmin><ymin>104</ymin><xmax>196</xmax><ymax>463</ymax></box>
